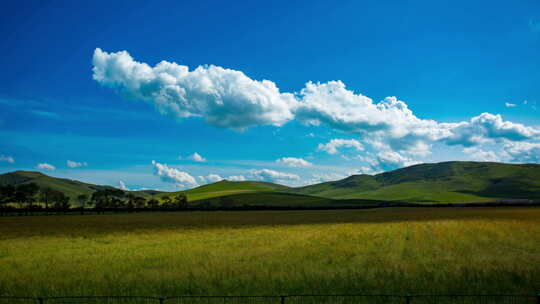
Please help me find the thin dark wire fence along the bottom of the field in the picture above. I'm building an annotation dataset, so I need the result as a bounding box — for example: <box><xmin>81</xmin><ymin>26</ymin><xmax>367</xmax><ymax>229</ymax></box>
<box><xmin>0</xmin><ymin>294</ymin><xmax>540</xmax><ymax>304</ymax></box>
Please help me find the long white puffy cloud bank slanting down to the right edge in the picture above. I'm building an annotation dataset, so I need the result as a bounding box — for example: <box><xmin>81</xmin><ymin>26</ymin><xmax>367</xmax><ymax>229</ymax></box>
<box><xmin>92</xmin><ymin>48</ymin><xmax>540</xmax><ymax>164</ymax></box>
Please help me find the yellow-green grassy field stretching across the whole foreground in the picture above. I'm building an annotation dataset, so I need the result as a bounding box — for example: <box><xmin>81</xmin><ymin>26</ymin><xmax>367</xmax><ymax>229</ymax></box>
<box><xmin>0</xmin><ymin>207</ymin><xmax>540</xmax><ymax>296</ymax></box>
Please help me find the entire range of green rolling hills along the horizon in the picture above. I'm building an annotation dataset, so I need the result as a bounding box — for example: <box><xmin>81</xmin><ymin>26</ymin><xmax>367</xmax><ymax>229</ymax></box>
<box><xmin>0</xmin><ymin>161</ymin><xmax>540</xmax><ymax>205</ymax></box>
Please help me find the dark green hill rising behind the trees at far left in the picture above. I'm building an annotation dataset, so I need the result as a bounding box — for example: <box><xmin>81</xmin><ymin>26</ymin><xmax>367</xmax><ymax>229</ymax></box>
<box><xmin>0</xmin><ymin>171</ymin><xmax>160</xmax><ymax>202</ymax></box>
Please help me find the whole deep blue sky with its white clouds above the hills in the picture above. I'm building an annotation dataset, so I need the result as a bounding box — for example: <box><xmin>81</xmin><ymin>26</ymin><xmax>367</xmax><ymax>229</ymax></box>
<box><xmin>0</xmin><ymin>1</ymin><xmax>540</xmax><ymax>190</ymax></box>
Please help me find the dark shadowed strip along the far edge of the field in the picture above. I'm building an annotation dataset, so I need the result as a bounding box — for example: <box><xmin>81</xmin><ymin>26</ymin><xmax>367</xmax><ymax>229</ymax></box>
<box><xmin>0</xmin><ymin>207</ymin><xmax>540</xmax><ymax>239</ymax></box>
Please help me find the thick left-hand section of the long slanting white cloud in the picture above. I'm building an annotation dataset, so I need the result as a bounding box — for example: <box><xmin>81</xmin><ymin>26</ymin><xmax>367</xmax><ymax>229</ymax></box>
<box><xmin>92</xmin><ymin>48</ymin><xmax>296</xmax><ymax>129</ymax></box>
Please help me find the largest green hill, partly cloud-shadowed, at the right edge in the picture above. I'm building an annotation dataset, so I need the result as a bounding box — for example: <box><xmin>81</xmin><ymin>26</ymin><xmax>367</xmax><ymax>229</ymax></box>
<box><xmin>292</xmin><ymin>162</ymin><xmax>540</xmax><ymax>202</ymax></box>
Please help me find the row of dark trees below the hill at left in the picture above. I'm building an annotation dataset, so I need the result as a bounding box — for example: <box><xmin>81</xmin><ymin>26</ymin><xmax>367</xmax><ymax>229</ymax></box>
<box><xmin>0</xmin><ymin>183</ymin><xmax>188</xmax><ymax>212</ymax></box>
